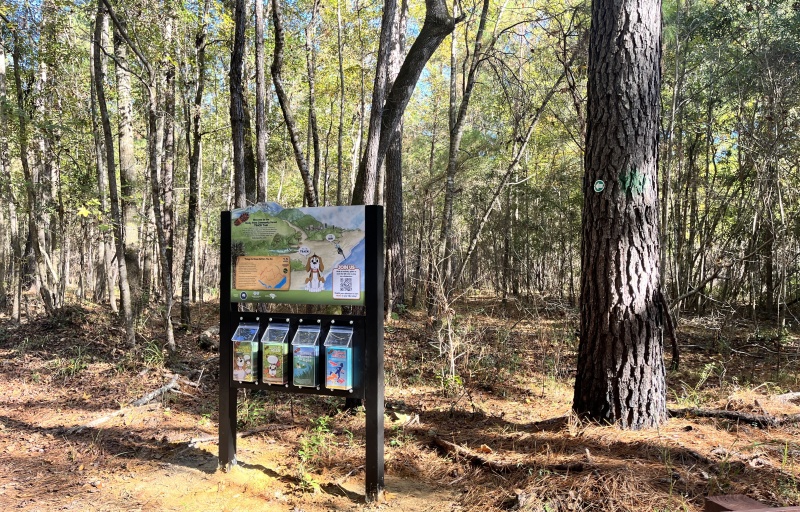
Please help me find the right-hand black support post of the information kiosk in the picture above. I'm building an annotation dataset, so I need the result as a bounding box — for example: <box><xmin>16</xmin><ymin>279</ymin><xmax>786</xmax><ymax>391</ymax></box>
<box><xmin>364</xmin><ymin>206</ymin><xmax>384</xmax><ymax>502</ymax></box>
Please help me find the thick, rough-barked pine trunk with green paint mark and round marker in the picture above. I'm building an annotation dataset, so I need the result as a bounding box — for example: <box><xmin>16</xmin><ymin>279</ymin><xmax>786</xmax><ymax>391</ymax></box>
<box><xmin>573</xmin><ymin>0</ymin><xmax>666</xmax><ymax>429</ymax></box>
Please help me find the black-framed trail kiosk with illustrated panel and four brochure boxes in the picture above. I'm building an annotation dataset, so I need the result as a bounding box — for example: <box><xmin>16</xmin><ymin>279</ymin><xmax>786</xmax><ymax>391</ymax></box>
<box><xmin>219</xmin><ymin>203</ymin><xmax>384</xmax><ymax>502</ymax></box>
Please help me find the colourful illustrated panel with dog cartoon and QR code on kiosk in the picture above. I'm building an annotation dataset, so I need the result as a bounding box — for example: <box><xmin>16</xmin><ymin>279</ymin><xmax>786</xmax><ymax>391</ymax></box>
<box><xmin>231</xmin><ymin>203</ymin><xmax>365</xmax><ymax>305</ymax></box>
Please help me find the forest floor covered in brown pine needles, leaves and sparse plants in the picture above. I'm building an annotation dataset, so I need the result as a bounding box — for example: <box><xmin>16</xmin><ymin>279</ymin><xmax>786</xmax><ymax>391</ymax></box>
<box><xmin>0</xmin><ymin>298</ymin><xmax>800</xmax><ymax>512</ymax></box>
